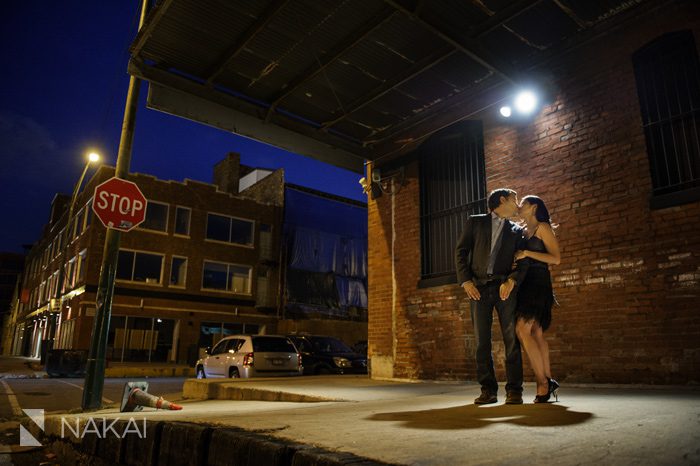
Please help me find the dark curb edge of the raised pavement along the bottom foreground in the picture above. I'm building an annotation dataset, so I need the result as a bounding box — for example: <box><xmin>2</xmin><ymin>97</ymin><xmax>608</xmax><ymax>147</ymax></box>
<box><xmin>39</xmin><ymin>419</ymin><xmax>400</xmax><ymax>466</ymax></box>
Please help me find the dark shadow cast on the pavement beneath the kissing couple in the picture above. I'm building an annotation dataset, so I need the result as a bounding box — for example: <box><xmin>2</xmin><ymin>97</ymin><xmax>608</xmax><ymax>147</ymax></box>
<box><xmin>367</xmin><ymin>403</ymin><xmax>593</xmax><ymax>429</ymax></box>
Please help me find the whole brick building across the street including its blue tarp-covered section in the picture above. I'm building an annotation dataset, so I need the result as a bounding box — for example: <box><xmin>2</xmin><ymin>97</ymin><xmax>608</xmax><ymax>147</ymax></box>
<box><xmin>6</xmin><ymin>153</ymin><xmax>367</xmax><ymax>364</ymax></box>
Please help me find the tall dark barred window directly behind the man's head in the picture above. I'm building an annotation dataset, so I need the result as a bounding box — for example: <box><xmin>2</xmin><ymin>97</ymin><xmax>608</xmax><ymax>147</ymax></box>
<box><xmin>418</xmin><ymin>121</ymin><xmax>486</xmax><ymax>279</ymax></box>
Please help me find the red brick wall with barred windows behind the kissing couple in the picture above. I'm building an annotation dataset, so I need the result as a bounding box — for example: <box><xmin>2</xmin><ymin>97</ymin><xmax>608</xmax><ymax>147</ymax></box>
<box><xmin>369</xmin><ymin>4</ymin><xmax>700</xmax><ymax>384</ymax></box>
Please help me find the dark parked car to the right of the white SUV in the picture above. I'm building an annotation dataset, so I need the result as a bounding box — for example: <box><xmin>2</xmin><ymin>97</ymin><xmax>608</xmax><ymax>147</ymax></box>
<box><xmin>287</xmin><ymin>335</ymin><xmax>367</xmax><ymax>375</ymax></box>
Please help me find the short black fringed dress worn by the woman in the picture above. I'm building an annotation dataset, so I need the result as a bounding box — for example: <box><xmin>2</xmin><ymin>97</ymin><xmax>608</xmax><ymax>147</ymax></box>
<box><xmin>515</xmin><ymin>235</ymin><xmax>554</xmax><ymax>330</ymax></box>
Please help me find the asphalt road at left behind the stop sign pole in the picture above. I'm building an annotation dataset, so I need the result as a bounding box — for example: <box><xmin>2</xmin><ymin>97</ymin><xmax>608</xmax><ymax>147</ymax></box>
<box><xmin>0</xmin><ymin>377</ymin><xmax>186</xmax><ymax>421</ymax></box>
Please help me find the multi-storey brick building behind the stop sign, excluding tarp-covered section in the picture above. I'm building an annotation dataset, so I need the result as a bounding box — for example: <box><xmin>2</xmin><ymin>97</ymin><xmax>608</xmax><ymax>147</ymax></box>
<box><xmin>15</xmin><ymin>154</ymin><xmax>281</xmax><ymax>362</ymax></box>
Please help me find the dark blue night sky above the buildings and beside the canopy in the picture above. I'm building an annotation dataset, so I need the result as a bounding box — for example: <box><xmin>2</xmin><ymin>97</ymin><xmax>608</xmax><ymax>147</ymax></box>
<box><xmin>0</xmin><ymin>0</ymin><xmax>366</xmax><ymax>252</ymax></box>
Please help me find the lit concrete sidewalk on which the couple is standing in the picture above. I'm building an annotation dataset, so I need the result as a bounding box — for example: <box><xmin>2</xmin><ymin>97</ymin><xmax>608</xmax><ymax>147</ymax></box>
<box><xmin>35</xmin><ymin>376</ymin><xmax>700</xmax><ymax>465</ymax></box>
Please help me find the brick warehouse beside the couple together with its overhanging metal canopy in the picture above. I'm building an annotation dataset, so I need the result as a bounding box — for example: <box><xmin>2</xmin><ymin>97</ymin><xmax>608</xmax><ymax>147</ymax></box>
<box><xmin>123</xmin><ymin>0</ymin><xmax>700</xmax><ymax>383</ymax></box>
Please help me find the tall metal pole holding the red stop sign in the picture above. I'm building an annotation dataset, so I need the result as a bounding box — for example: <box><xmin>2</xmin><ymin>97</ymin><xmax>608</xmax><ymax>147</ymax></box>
<box><xmin>82</xmin><ymin>0</ymin><xmax>148</xmax><ymax>410</ymax></box>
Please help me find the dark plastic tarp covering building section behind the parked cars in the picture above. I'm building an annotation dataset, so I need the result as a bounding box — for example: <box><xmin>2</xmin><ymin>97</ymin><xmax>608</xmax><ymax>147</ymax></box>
<box><xmin>284</xmin><ymin>187</ymin><xmax>367</xmax><ymax>315</ymax></box>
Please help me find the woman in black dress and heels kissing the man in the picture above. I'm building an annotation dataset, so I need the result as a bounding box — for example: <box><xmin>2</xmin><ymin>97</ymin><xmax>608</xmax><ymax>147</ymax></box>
<box><xmin>515</xmin><ymin>196</ymin><xmax>560</xmax><ymax>403</ymax></box>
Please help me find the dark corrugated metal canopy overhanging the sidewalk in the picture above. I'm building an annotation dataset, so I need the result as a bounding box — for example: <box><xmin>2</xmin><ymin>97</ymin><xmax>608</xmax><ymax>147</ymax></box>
<box><xmin>129</xmin><ymin>0</ymin><xmax>668</xmax><ymax>172</ymax></box>
